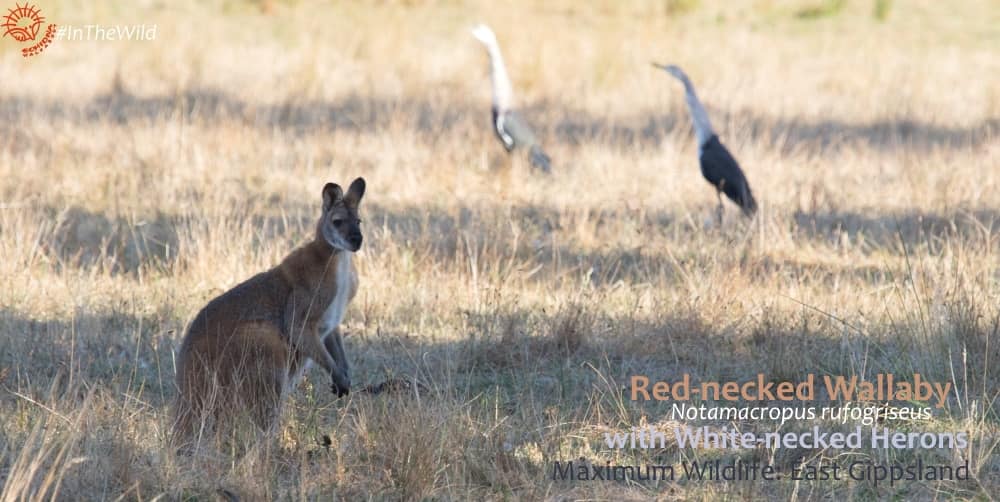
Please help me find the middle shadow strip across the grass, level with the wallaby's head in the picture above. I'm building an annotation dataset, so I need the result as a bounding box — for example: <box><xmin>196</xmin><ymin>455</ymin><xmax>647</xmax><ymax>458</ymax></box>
<box><xmin>19</xmin><ymin>203</ymin><xmax>1000</xmax><ymax>285</ymax></box>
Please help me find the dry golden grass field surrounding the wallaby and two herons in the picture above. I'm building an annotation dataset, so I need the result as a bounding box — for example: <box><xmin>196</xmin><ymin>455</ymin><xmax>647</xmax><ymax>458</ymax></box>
<box><xmin>0</xmin><ymin>0</ymin><xmax>1000</xmax><ymax>501</ymax></box>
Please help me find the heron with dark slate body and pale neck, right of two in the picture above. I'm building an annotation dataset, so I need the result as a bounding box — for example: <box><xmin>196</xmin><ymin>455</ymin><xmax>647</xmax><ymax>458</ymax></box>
<box><xmin>653</xmin><ymin>63</ymin><xmax>757</xmax><ymax>222</ymax></box>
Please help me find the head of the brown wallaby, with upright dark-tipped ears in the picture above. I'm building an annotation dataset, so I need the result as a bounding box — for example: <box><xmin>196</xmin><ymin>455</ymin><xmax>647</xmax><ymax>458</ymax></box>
<box><xmin>319</xmin><ymin>178</ymin><xmax>365</xmax><ymax>252</ymax></box>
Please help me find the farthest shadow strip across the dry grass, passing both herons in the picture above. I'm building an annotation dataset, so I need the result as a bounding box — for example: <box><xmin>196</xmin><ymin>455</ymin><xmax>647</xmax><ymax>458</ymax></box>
<box><xmin>0</xmin><ymin>88</ymin><xmax>1000</xmax><ymax>152</ymax></box>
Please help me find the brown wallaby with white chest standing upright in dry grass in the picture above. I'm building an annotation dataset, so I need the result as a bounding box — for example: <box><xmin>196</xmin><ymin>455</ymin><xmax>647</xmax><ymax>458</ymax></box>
<box><xmin>174</xmin><ymin>178</ymin><xmax>365</xmax><ymax>448</ymax></box>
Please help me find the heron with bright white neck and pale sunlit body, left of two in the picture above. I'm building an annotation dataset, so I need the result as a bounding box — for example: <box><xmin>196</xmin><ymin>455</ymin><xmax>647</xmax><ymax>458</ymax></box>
<box><xmin>472</xmin><ymin>24</ymin><xmax>552</xmax><ymax>173</ymax></box>
